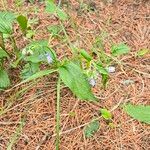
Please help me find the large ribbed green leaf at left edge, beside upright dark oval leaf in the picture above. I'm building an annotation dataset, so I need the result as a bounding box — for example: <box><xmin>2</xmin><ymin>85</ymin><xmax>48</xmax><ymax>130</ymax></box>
<box><xmin>0</xmin><ymin>12</ymin><xmax>15</xmax><ymax>34</ymax></box>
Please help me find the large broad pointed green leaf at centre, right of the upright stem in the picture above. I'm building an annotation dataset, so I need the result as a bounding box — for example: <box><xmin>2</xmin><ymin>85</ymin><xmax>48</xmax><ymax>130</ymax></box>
<box><xmin>58</xmin><ymin>62</ymin><xmax>96</xmax><ymax>101</ymax></box>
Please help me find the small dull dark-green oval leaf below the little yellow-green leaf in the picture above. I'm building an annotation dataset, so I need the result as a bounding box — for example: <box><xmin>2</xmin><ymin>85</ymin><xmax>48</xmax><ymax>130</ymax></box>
<box><xmin>84</xmin><ymin>120</ymin><xmax>100</xmax><ymax>138</ymax></box>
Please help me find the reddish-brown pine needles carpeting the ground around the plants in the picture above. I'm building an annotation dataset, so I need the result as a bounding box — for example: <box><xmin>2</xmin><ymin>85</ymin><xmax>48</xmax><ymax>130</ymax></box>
<box><xmin>0</xmin><ymin>0</ymin><xmax>150</xmax><ymax>150</ymax></box>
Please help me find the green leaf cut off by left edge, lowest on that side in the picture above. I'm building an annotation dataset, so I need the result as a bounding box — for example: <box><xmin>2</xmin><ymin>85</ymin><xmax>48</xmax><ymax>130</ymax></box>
<box><xmin>0</xmin><ymin>69</ymin><xmax>10</xmax><ymax>88</ymax></box>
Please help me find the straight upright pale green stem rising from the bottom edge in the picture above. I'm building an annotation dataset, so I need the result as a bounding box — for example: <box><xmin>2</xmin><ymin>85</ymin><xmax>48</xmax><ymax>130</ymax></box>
<box><xmin>56</xmin><ymin>77</ymin><xmax>60</xmax><ymax>150</ymax></box>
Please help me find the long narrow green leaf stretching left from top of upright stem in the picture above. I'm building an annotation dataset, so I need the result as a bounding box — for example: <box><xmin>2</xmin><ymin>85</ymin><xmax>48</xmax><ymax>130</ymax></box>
<box><xmin>20</xmin><ymin>69</ymin><xmax>57</xmax><ymax>84</ymax></box>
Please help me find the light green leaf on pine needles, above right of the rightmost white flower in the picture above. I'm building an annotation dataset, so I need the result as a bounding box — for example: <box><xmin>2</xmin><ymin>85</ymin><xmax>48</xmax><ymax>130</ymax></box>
<box><xmin>111</xmin><ymin>43</ymin><xmax>130</xmax><ymax>56</ymax></box>
